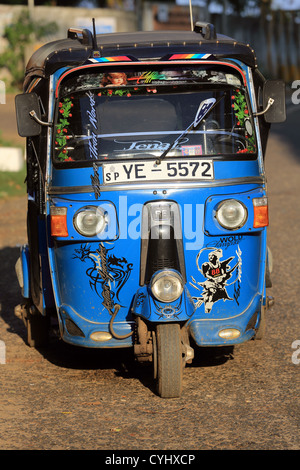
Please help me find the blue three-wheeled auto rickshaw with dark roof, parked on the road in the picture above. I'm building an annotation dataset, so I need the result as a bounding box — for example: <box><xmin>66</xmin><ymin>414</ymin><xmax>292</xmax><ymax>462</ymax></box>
<box><xmin>16</xmin><ymin>23</ymin><xmax>285</xmax><ymax>398</ymax></box>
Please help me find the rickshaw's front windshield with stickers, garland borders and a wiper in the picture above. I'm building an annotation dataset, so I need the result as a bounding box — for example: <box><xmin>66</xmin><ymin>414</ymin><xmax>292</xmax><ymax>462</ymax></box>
<box><xmin>54</xmin><ymin>65</ymin><xmax>256</xmax><ymax>163</ymax></box>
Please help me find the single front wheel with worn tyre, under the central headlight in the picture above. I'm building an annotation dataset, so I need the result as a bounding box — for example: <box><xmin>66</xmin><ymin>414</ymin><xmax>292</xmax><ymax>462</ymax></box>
<box><xmin>153</xmin><ymin>323</ymin><xmax>183</xmax><ymax>398</ymax></box>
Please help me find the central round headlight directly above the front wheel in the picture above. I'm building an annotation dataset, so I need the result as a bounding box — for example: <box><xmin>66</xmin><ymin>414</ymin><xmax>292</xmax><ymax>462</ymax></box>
<box><xmin>151</xmin><ymin>269</ymin><xmax>183</xmax><ymax>302</ymax></box>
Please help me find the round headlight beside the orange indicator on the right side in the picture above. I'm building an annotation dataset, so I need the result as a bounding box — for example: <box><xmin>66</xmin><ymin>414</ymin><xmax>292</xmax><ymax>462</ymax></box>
<box><xmin>216</xmin><ymin>199</ymin><xmax>248</xmax><ymax>230</ymax></box>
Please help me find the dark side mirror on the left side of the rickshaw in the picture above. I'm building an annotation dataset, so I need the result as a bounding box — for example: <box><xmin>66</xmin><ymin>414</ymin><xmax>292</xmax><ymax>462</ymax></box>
<box><xmin>15</xmin><ymin>93</ymin><xmax>42</xmax><ymax>137</ymax></box>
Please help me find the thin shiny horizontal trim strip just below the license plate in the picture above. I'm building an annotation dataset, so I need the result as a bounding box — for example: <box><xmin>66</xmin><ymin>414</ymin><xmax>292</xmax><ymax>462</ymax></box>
<box><xmin>47</xmin><ymin>176</ymin><xmax>265</xmax><ymax>195</ymax></box>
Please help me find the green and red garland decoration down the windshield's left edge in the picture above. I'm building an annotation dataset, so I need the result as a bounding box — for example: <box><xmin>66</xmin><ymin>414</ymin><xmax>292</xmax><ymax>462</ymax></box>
<box><xmin>55</xmin><ymin>98</ymin><xmax>73</xmax><ymax>162</ymax></box>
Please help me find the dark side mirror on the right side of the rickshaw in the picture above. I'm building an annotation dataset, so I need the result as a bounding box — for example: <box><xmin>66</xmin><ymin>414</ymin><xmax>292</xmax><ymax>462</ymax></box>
<box><xmin>263</xmin><ymin>80</ymin><xmax>286</xmax><ymax>123</ymax></box>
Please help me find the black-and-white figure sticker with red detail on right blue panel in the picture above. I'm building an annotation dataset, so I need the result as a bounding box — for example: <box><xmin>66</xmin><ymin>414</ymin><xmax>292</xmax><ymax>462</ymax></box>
<box><xmin>190</xmin><ymin>246</ymin><xmax>242</xmax><ymax>313</ymax></box>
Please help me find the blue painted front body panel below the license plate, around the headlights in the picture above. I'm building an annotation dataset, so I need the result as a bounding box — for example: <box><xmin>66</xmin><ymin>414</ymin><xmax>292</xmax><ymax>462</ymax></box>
<box><xmin>49</xmin><ymin>178</ymin><xmax>266</xmax><ymax>347</ymax></box>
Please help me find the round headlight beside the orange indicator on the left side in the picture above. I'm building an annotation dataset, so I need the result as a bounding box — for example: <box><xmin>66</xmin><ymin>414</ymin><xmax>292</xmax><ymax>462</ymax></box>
<box><xmin>73</xmin><ymin>206</ymin><xmax>106</xmax><ymax>237</ymax></box>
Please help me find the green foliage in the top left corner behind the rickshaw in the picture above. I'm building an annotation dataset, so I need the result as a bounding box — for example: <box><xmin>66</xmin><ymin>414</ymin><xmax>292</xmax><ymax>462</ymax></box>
<box><xmin>0</xmin><ymin>10</ymin><xmax>57</xmax><ymax>88</ymax></box>
